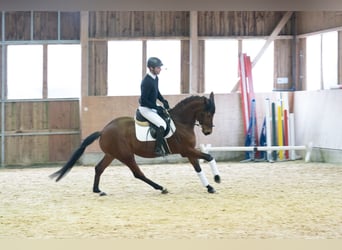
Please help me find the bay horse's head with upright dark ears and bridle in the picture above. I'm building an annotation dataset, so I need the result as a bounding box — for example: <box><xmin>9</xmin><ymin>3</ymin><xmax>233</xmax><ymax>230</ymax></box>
<box><xmin>196</xmin><ymin>92</ymin><xmax>215</xmax><ymax>135</ymax></box>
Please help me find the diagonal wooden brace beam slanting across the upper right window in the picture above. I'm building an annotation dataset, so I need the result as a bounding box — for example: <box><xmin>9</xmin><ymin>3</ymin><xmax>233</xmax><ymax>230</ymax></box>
<box><xmin>231</xmin><ymin>11</ymin><xmax>293</xmax><ymax>92</ymax></box>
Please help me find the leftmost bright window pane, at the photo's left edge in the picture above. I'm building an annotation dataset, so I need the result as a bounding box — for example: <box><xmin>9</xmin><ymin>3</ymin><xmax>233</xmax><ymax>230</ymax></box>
<box><xmin>7</xmin><ymin>45</ymin><xmax>43</xmax><ymax>99</ymax></box>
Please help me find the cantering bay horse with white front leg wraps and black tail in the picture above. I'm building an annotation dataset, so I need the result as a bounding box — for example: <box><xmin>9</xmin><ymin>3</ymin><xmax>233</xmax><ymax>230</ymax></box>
<box><xmin>50</xmin><ymin>92</ymin><xmax>221</xmax><ymax>195</ymax></box>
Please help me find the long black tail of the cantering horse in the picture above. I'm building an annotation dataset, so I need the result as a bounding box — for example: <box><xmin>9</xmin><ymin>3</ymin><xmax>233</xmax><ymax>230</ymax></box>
<box><xmin>50</xmin><ymin>131</ymin><xmax>101</xmax><ymax>181</ymax></box>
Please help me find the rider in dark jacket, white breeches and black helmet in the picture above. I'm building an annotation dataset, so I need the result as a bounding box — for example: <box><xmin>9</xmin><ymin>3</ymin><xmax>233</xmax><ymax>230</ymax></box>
<box><xmin>139</xmin><ymin>57</ymin><xmax>170</xmax><ymax>156</ymax></box>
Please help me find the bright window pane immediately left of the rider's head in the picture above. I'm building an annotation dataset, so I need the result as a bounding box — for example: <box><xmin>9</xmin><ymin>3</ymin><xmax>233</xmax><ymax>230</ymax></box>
<box><xmin>108</xmin><ymin>41</ymin><xmax>142</xmax><ymax>96</ymax></box>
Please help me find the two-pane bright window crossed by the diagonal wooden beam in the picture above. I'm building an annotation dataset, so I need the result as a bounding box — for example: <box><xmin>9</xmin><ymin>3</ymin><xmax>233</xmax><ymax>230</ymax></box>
<box><xmin>205</xmin><ymin>39</ymin><xmax>274</xmax><ymax>93</ymax></box>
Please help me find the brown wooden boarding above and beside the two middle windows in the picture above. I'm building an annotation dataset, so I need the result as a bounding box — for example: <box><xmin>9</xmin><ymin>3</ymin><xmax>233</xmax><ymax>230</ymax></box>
<box><xmin>84</xmin><ymin>11</ymin><xmax>292</xmax><ymax>96</ymax></box>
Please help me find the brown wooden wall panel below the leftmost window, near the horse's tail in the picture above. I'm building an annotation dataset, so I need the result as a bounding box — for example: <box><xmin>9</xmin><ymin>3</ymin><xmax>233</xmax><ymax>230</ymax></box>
<box><xmin>4</xmin><ymin>100</ymin><xmax>80</xmax><ymax>165</ymax></box>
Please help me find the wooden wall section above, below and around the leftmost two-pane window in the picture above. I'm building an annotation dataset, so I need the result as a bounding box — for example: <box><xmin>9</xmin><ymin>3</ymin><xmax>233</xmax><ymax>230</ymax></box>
<box><xmin>0</xmin><ymin>11</ymin><xmax>81</xmax><ymax>165</ymax></box>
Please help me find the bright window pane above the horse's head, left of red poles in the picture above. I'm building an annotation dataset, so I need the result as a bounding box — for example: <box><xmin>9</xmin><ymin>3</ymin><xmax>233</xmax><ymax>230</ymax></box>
<box><xmin>204</xmin><ymin>40</ymin><xmax>239</xmax><ymax>93</ymax></box>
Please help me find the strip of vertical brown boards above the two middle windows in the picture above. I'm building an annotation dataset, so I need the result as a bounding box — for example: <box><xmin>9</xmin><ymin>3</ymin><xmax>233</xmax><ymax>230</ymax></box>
<box><xmin>89</xmin><ymin>11</ymin><xmax>292</xmax><ymax>39</ymax></box>
